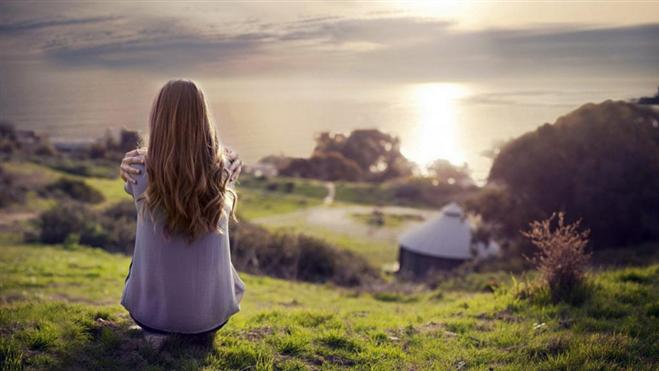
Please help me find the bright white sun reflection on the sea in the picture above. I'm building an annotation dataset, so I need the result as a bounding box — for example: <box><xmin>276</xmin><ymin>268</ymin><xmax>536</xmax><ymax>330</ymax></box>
<box><xmin>403</xmin><ymin>83</ymin><xmax>467</xmax><ymax>167</ymax></box>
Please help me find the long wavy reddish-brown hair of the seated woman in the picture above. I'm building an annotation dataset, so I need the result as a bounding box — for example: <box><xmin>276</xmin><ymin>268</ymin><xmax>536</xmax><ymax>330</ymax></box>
<box><xmin>145</xmin><ymin>80</ymin><xmax>236</xmax><ymax>241</ymax></box>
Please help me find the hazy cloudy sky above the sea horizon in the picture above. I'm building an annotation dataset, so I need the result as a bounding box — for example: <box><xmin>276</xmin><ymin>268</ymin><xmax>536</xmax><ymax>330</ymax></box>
<box><xmin>0</xmin><ymin>1</ymin><xmax>659</xmax><ymax>82</ymax></box>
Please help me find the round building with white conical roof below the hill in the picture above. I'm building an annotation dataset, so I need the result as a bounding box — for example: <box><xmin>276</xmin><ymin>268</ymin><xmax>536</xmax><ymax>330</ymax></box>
<box><xmin>398</xmin><ymin>203</ymin><xmax>500</xmax><ymax>278</ymax></box>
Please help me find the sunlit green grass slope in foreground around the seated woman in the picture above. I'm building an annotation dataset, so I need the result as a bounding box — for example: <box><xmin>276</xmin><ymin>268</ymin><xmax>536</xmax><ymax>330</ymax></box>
<box><xmin>0</xmin><ymin>240</ymin><xmax>659</xmax><ymax>370</ymax></box>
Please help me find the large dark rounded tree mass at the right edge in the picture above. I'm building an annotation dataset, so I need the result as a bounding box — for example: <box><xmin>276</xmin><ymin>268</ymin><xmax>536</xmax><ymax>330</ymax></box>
<box><xmin>468</xmin><ymin>101</ymin><xmax>659</xmax><ymax>249</ymax></box>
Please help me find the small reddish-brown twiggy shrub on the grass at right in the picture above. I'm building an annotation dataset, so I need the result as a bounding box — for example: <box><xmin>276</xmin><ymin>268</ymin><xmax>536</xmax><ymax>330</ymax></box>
<box><xmin>522</xmin><ymin>212</ymin><xmax>590</xmax><ymax>302</ymax></box>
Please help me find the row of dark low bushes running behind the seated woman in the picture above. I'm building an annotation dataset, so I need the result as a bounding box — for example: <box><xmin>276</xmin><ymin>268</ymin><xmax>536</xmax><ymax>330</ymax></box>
<box><xmin>36</xmin><ymin>201</ymin><xmax>379</xmax><ymax>286</ymax></box>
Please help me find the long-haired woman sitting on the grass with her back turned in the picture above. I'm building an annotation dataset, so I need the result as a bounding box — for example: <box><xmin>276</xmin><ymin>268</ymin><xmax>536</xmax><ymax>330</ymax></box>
<box><xmin>121</xmin><ymin>80</ymin><xmax>245</xmax><ymax>334</ymax></box>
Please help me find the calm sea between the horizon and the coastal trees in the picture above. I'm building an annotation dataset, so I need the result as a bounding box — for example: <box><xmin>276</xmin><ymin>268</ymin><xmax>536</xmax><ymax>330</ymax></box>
<box><xmin>0</xmin><ymin>69</ymin><xmax>657</xmax><ymax>183</ymax></box>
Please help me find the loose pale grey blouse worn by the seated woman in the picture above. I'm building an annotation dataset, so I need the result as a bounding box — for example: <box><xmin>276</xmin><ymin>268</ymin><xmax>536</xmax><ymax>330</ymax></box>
<box><xmin>121</xmin><ymin>165</ymin><xmax>245</xmax><ymax>334</ymax></box>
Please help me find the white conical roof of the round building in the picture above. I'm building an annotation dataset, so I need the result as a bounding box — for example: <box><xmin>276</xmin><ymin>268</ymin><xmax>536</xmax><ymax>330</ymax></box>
<box><xmin>399</xmin><ymin>202</ymin><xmax>473</xmax><ymax>259</ymax></box>
